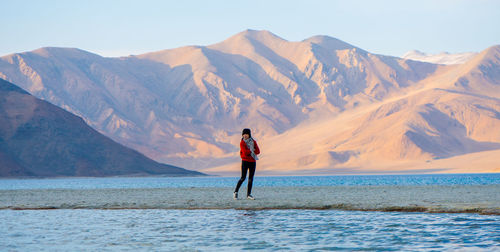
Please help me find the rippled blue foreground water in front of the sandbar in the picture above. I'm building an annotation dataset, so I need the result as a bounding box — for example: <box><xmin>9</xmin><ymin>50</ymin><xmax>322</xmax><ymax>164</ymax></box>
<box><xmin>0</xmin><ymin>209</ymin><xmax>500</xmax><ymax>251</ymax></box>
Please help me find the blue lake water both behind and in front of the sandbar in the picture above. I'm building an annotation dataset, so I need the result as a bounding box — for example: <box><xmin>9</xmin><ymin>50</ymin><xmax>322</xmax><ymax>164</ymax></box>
<box><xmin>0</xmin><ymin>174</ymin><xmax>500</xmax><ymax>251</ymax></box>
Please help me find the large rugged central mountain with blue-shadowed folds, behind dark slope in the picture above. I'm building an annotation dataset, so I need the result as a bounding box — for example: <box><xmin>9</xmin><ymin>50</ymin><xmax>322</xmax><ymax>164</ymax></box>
<box><xmin>0</xmin><ymin>30</ymin><xmax>436</xmax><ymax>169</ymax></box>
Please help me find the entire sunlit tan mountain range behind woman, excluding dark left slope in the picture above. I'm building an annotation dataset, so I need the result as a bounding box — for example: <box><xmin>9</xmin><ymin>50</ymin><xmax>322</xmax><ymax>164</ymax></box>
<box><xmin>0</xmin><ymin>30</ymin><xmax>500</xmax><ymax>174</ymax></box>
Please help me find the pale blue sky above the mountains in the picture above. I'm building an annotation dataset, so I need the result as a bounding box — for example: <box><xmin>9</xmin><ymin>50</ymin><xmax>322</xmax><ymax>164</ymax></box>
<box><xmin>0</xmin><ymin>0</ymin><xmax>500</xmax><ymax>57</ymax></box>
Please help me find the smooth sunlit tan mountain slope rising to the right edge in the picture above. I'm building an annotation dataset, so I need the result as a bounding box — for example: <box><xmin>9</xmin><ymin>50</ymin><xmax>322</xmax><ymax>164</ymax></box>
<box><xmin>211</xmin><ymin>46</ymin><xmax>500</xmax><ymax>174</ymax></box>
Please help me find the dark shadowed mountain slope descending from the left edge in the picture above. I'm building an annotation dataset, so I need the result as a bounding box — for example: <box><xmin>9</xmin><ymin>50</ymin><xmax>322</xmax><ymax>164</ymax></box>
<box><xmin>0</xmin><ymin>79</ymin><xmax>201</xmax><ymax>177</ymax></box>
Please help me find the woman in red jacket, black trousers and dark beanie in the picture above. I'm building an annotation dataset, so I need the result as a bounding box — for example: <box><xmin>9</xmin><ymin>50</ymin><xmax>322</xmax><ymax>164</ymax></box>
<box><xmin>233</xmin><ymin>129</ymin><xmax>260</xmax><ymax>200</ymax></box>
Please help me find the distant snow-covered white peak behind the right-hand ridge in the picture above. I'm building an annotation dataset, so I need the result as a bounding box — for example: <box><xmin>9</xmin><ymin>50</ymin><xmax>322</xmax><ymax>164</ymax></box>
<box><xmin>402</xmin><ymin>50</ymin><xmax>477</xmax><ymax>65</ymax></box>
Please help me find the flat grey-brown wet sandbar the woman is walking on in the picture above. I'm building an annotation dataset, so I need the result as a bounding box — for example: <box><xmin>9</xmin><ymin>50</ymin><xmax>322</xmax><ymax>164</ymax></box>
<box><xmin>0</xmin><ymin>185</ymin><xmax>500</xmax><ymax>215</ymax></box>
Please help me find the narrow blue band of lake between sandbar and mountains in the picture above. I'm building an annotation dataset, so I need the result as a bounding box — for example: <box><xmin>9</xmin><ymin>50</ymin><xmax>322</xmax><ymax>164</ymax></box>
<box><xmin>0</xmin><ymin>173</ymin><xmax>500</xmax><ymax>190</ymax></box>
